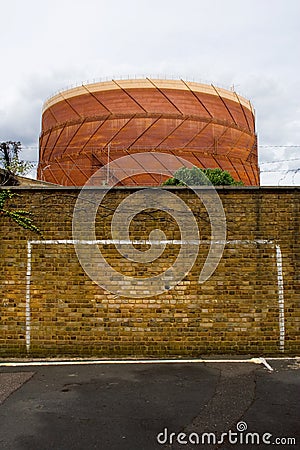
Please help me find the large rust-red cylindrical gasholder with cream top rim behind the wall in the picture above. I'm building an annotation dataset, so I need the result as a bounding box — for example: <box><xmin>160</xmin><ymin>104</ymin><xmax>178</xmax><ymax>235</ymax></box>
<box><xmin>38</xmin><ymin>78</ymin><xmax>259</xmax><ymax>186</ymax></box>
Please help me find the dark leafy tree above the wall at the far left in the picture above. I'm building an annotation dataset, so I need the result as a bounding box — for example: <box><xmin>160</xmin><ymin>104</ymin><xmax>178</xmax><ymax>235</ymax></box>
<box><xmin>0</xmin><ymin>141</ymin><xmax>33</xmax><ymax>176</ymax></box>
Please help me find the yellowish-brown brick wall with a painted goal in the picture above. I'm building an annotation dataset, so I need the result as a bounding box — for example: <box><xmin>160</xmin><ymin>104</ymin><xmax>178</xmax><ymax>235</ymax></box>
<box><xmin>0</xmin><ymin>187</ymin><xmax>300</xmax><ymax>357</ymax></box>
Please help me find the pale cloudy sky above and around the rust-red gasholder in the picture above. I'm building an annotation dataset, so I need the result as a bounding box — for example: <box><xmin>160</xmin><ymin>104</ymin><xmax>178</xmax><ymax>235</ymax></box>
<box><xmin>0</xmin><ymin>0</ymin><xmax>300</xmax><ymax>185</ymax></box>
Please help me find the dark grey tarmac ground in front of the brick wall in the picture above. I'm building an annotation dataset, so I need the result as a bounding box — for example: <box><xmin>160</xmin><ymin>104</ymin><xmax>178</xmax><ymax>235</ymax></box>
<box><xmin>0</xmin><ymin>359</ymin><xmax>300</xmax><ymax>450</ymax></box>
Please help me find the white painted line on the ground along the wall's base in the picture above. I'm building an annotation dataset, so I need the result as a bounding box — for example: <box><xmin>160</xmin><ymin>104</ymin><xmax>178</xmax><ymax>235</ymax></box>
<box><xmin>0</xmin><ymin>358</ymin><xmax>273</xmax><ymax>371</ymax></box>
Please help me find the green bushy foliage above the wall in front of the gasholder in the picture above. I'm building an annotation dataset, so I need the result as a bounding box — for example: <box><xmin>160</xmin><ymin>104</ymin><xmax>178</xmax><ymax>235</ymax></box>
<box><xmin>163</xmin><ymin>166</ymin><xmax>243</xmax><ymax>186</ymax></box>
